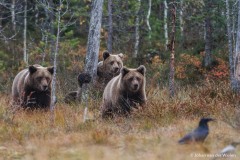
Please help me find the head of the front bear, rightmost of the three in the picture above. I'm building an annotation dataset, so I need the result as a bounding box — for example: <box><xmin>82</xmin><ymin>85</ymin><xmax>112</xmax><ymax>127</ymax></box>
<box><xmin>121</xmin><ymin>65</ymin><xmax>146</xmax><ymax>93</ymax></box>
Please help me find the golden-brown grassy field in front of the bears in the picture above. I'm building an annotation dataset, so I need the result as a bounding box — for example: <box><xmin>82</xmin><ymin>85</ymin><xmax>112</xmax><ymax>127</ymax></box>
<box><xmin>0</xmin><ymin>82</ymin><xmax>240</xmax><ymax>160</ymax></box>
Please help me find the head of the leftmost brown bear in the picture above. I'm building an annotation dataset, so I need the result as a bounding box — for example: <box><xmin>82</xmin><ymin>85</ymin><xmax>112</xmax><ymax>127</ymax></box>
<box><xmin>27</xmin><ymin>65</ymin><xmax>54</xmax><ymax>92</ymax></box>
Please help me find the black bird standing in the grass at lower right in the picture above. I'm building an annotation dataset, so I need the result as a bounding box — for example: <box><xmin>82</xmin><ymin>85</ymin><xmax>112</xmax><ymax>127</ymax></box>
<box><xmin>178</xmin><ymin>118</ymin><xmax>214</xmax><ymax>144</ymax></box>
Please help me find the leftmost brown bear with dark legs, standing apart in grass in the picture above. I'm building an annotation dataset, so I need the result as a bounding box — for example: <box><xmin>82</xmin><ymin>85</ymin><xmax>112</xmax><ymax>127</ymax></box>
<box><xmin>12</xmin><ymin>64</ymin><xmax>54</xmax><ymax>108</ymax></box>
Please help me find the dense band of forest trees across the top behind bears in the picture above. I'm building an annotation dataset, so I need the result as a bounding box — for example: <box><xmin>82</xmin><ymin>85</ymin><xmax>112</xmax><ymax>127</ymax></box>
<box><xmin>0</xmin><ymin>0</ymin><xmax>240</xmax><ymax>92</ymax></box>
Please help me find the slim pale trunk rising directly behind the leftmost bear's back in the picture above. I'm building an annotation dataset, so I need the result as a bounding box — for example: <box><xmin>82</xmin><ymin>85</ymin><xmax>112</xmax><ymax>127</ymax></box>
<box><xmin>23</xmin><ymin>0</ymin><xmax>28</xmax><ymax>65</ymax></box>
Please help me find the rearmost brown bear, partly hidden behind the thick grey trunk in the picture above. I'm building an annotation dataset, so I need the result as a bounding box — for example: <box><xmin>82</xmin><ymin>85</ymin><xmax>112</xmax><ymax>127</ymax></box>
<box><xmin>64</xmin><ymin>51</ymin><xmax>123</xmax><ymax>103</ymax></box>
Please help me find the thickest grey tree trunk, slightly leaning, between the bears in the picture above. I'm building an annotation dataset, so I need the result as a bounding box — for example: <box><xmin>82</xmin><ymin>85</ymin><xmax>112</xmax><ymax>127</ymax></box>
<box><xmin>78</xmin><ymin>0</ymin><xmax>103</xmax><ymax>122</ymax></box>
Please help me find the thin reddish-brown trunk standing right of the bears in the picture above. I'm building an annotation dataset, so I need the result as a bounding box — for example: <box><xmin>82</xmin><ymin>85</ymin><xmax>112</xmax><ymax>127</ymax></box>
<box><xmin>169</xmin><ymin>4</ymin><xmax>176</xmax><ymax>98</ymax></box>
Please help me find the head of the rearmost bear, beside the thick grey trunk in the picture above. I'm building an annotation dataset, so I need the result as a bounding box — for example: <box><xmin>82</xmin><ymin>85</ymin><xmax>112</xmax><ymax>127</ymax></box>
<box><xmin>103</xmin><ymin>51</ymin><xmax>123</xmax><ymax>75</ymax></box>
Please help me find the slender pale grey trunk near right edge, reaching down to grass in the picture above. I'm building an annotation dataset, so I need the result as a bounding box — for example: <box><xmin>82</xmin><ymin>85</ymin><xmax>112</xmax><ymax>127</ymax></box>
<box><xmin>226</xmin><ymin>0</ymin><xmax>235</xmax><ymax>89</ymax></box>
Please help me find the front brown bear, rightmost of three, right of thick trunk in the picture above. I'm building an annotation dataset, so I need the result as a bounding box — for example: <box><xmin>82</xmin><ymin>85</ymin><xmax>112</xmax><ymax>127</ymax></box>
<box><xmin>101</xmin><ymin>65</ymin><xmax>147</xmax><ymax>118</ymax></box>
